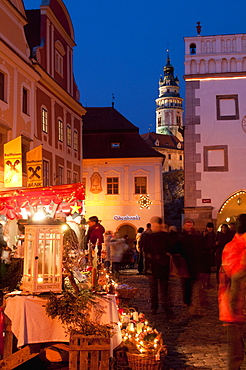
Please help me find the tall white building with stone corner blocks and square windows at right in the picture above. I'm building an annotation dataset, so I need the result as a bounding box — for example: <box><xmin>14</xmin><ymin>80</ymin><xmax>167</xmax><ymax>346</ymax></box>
<box><xmin>184</xmin><ymin>30</ymin><xmax>246</xmax><ymax>229</ymax></box>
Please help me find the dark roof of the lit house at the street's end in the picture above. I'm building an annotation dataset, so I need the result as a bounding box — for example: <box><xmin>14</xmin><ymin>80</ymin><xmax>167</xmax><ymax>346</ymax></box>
<box><xmin>83</xmin><ymin>107</ymin><xmax>164</xmax><ymax>159</ymax></box>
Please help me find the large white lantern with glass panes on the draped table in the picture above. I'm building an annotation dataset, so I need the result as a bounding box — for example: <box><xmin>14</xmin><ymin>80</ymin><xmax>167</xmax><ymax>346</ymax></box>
<box><xmin>22</xmin><ymin>225</ymin><xmax>63</xmax><ymax>293</ymax></box>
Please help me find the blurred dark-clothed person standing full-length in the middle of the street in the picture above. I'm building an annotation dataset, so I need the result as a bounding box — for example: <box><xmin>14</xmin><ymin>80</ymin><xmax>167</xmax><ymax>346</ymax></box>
<box><xmin>142</xmin><ymin>216</ymin><xmax>171</xmax><ymax>315</ymax></box>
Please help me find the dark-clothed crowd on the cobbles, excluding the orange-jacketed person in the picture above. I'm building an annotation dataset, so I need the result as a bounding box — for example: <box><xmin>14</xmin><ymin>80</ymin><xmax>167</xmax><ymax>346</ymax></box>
<box><xmin>87</xmin><ymin>216</ymin><xmax>235</xmax><ymax>314</ymax></box>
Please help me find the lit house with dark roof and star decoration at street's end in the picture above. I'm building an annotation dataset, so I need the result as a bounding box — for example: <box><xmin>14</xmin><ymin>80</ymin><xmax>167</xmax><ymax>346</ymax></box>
<box><xmin>83</xmin><ymin>107</ymin><xmax>164</xmax><ymax>241</ymax></box>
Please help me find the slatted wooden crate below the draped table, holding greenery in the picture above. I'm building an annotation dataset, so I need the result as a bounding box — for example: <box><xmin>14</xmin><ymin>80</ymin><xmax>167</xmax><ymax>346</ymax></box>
<box><xmin>69</xmin><ymin>334</ymin><xmax>110</xmax><ymax>370</ymax></box>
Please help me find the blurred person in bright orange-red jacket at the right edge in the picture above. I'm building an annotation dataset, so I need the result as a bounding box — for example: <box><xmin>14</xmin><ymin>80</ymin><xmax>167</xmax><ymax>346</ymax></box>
<box><xmin>219</xmin><ymin>214</ymin><xmax>246</xmax><ymax>370</ymax></box>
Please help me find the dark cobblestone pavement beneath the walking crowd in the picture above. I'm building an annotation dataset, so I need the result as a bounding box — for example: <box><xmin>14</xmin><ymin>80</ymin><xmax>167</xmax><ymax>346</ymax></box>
<box><xmin>120</xmin><ymin>270</ymin><xmax>246</xmax><ymax>370</ymax></box>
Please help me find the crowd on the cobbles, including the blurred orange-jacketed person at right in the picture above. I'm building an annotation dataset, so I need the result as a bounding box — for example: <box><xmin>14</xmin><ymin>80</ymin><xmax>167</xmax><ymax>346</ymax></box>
<box><xmin>86</xmin><ymin>214</ymin><xmax>246</xmax><ymax>370</ymax></box>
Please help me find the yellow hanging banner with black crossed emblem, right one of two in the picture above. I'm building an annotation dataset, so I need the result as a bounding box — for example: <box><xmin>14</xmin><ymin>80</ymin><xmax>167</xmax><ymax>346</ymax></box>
<box><xmin>26</xmin><ymin>145</ymin><xmax>43</xmax><ymax>188</ymax></box>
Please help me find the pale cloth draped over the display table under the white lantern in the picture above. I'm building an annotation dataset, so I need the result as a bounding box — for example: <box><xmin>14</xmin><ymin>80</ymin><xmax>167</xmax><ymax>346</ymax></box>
<box><xmin>4</xmin><ymin>295</ymin><xmax>122</xmax><ymax>355</ymax></box>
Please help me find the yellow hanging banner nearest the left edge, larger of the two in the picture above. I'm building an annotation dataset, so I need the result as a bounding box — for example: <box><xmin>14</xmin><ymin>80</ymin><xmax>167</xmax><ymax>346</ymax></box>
<box><xmin>4</xmin><ymin>136</ymin><xmax>22</xmax><ymax>188</ymax></box>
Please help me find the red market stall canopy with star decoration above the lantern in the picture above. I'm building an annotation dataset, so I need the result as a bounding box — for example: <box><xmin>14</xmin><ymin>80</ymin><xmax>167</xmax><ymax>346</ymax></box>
<box><xmin>0</xmin><ymin>183</ymin><xmax>85</xmax><ymax>220</ymax></box>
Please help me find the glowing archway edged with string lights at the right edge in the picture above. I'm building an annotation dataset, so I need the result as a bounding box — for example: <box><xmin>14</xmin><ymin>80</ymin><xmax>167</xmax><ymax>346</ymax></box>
<box><xmin>216</xmin><ymin>190</ymin><xmax>246</xmax><ymax>228</ymax></box>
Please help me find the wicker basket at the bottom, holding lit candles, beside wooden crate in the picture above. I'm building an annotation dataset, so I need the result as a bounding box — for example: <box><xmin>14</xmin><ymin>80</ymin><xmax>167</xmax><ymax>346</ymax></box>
<box><xmin>127</xmin><ymin>347</ymin><xmax>167</xmax><ymax>370</ymax></box>
